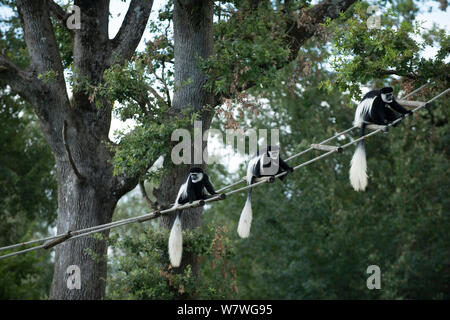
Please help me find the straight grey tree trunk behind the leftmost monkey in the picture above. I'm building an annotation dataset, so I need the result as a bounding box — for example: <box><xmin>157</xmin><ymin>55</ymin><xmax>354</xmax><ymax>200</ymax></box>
<box><xmin>154</xmin><ymin>0</ymin><xmax>215</xmax><ymax>275</ymax></box>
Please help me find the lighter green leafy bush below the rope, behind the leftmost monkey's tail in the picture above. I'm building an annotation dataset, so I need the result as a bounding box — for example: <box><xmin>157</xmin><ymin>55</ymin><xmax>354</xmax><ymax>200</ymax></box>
<box><xmin>107</xmin><ymin>198</ymin><xmax>237</xmax><ymax>299</ymax></box>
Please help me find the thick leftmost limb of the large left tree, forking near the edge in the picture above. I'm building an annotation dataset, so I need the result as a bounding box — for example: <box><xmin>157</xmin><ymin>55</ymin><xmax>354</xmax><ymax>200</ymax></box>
<box><xmin>12</xmin><ymin>0</ymin><xmax>70</xmax><ymax>151</ymax></box>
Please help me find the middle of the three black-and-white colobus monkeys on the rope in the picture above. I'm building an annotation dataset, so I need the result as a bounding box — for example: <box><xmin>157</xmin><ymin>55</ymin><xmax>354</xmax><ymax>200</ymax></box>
<box><xmin>237</xmin><ymin>146</ymin><xmax>294</xmax><ymax>238</ymax></box>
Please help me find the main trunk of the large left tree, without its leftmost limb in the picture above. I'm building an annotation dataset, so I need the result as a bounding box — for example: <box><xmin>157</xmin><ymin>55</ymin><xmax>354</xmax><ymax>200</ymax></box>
<box><xmin>42</xmin><ymin>0</ymin><xmax>153</xmax><ymax>299</ymax></box>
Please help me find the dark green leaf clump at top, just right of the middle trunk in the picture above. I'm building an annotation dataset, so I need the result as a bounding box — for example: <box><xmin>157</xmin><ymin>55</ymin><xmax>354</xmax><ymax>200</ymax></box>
<box><xmin>203</xmin><ymin>1</ymin><xmax>289</xmax><ymax>95</ymax></box>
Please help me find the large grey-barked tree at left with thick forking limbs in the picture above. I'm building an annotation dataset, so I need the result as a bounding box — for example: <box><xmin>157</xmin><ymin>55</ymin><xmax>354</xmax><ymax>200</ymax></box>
<box><xmin>0</xmin><ymin>0</ymin><xmax>153</xmax><ymax>299</ymax></box>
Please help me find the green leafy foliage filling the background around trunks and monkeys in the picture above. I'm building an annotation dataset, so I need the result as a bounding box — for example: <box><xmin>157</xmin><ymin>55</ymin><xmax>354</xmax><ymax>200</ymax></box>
<box><xmin>0</xmin><ymin>0</ymin><xmax>450</xmax><ymax>299</ymax></box>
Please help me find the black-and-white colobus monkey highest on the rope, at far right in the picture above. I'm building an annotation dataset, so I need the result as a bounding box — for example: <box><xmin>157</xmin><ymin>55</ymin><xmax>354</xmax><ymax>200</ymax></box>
<box><xmin>350</xmin><ymin>87</ymin><xmax>412</xmax><ymax>191</ymax></box>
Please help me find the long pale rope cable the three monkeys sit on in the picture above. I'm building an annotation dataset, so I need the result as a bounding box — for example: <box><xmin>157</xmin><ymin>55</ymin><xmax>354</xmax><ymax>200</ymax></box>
<box><xmin>0</xmin><ymin>83</ymin><xmax>442</xmax><ymax>260</ymax></box>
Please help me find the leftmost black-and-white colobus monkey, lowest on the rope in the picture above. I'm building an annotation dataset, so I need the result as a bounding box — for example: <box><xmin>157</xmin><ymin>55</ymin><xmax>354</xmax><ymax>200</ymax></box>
<box><xmin>169</xmin><ymin>167</ymin><xmax>216</xmax><ymax>267</ymax></box>
